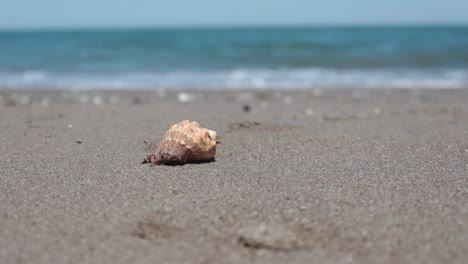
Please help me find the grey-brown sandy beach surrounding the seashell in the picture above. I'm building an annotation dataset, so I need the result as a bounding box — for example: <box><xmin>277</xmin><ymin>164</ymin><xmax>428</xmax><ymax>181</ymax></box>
<box><xmin>0</xmin><ymin>90</ymin><xmax>468</xmax><ymax>263</ymax></box>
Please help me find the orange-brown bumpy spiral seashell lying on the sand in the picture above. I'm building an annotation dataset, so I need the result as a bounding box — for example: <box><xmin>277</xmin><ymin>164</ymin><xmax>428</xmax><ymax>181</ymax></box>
<box><xmin>143</xmin><ymin>120</ymin><xmax>216</xmax><ymax>165</ymax></box>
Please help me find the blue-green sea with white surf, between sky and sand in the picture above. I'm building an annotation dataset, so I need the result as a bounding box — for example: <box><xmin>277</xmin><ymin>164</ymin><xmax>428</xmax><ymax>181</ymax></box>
<box><xmin>0</xmin><ymin>26</ymin><xmax>468</xmax><ymax>89</ymax></box>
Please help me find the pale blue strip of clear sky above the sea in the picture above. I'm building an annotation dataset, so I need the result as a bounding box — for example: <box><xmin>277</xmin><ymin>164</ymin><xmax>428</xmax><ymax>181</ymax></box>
<box><xmin>0</xmin><ymin>0</ymin><xmax>468</xmax><ymax>29</ymax></box>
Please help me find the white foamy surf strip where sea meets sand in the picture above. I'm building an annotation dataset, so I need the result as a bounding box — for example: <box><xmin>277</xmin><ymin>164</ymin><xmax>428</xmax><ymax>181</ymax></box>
<box><xmin>0</xmin><ymin>68</ymin><xmax>468</xmax><ymax>90</ymax></box>
